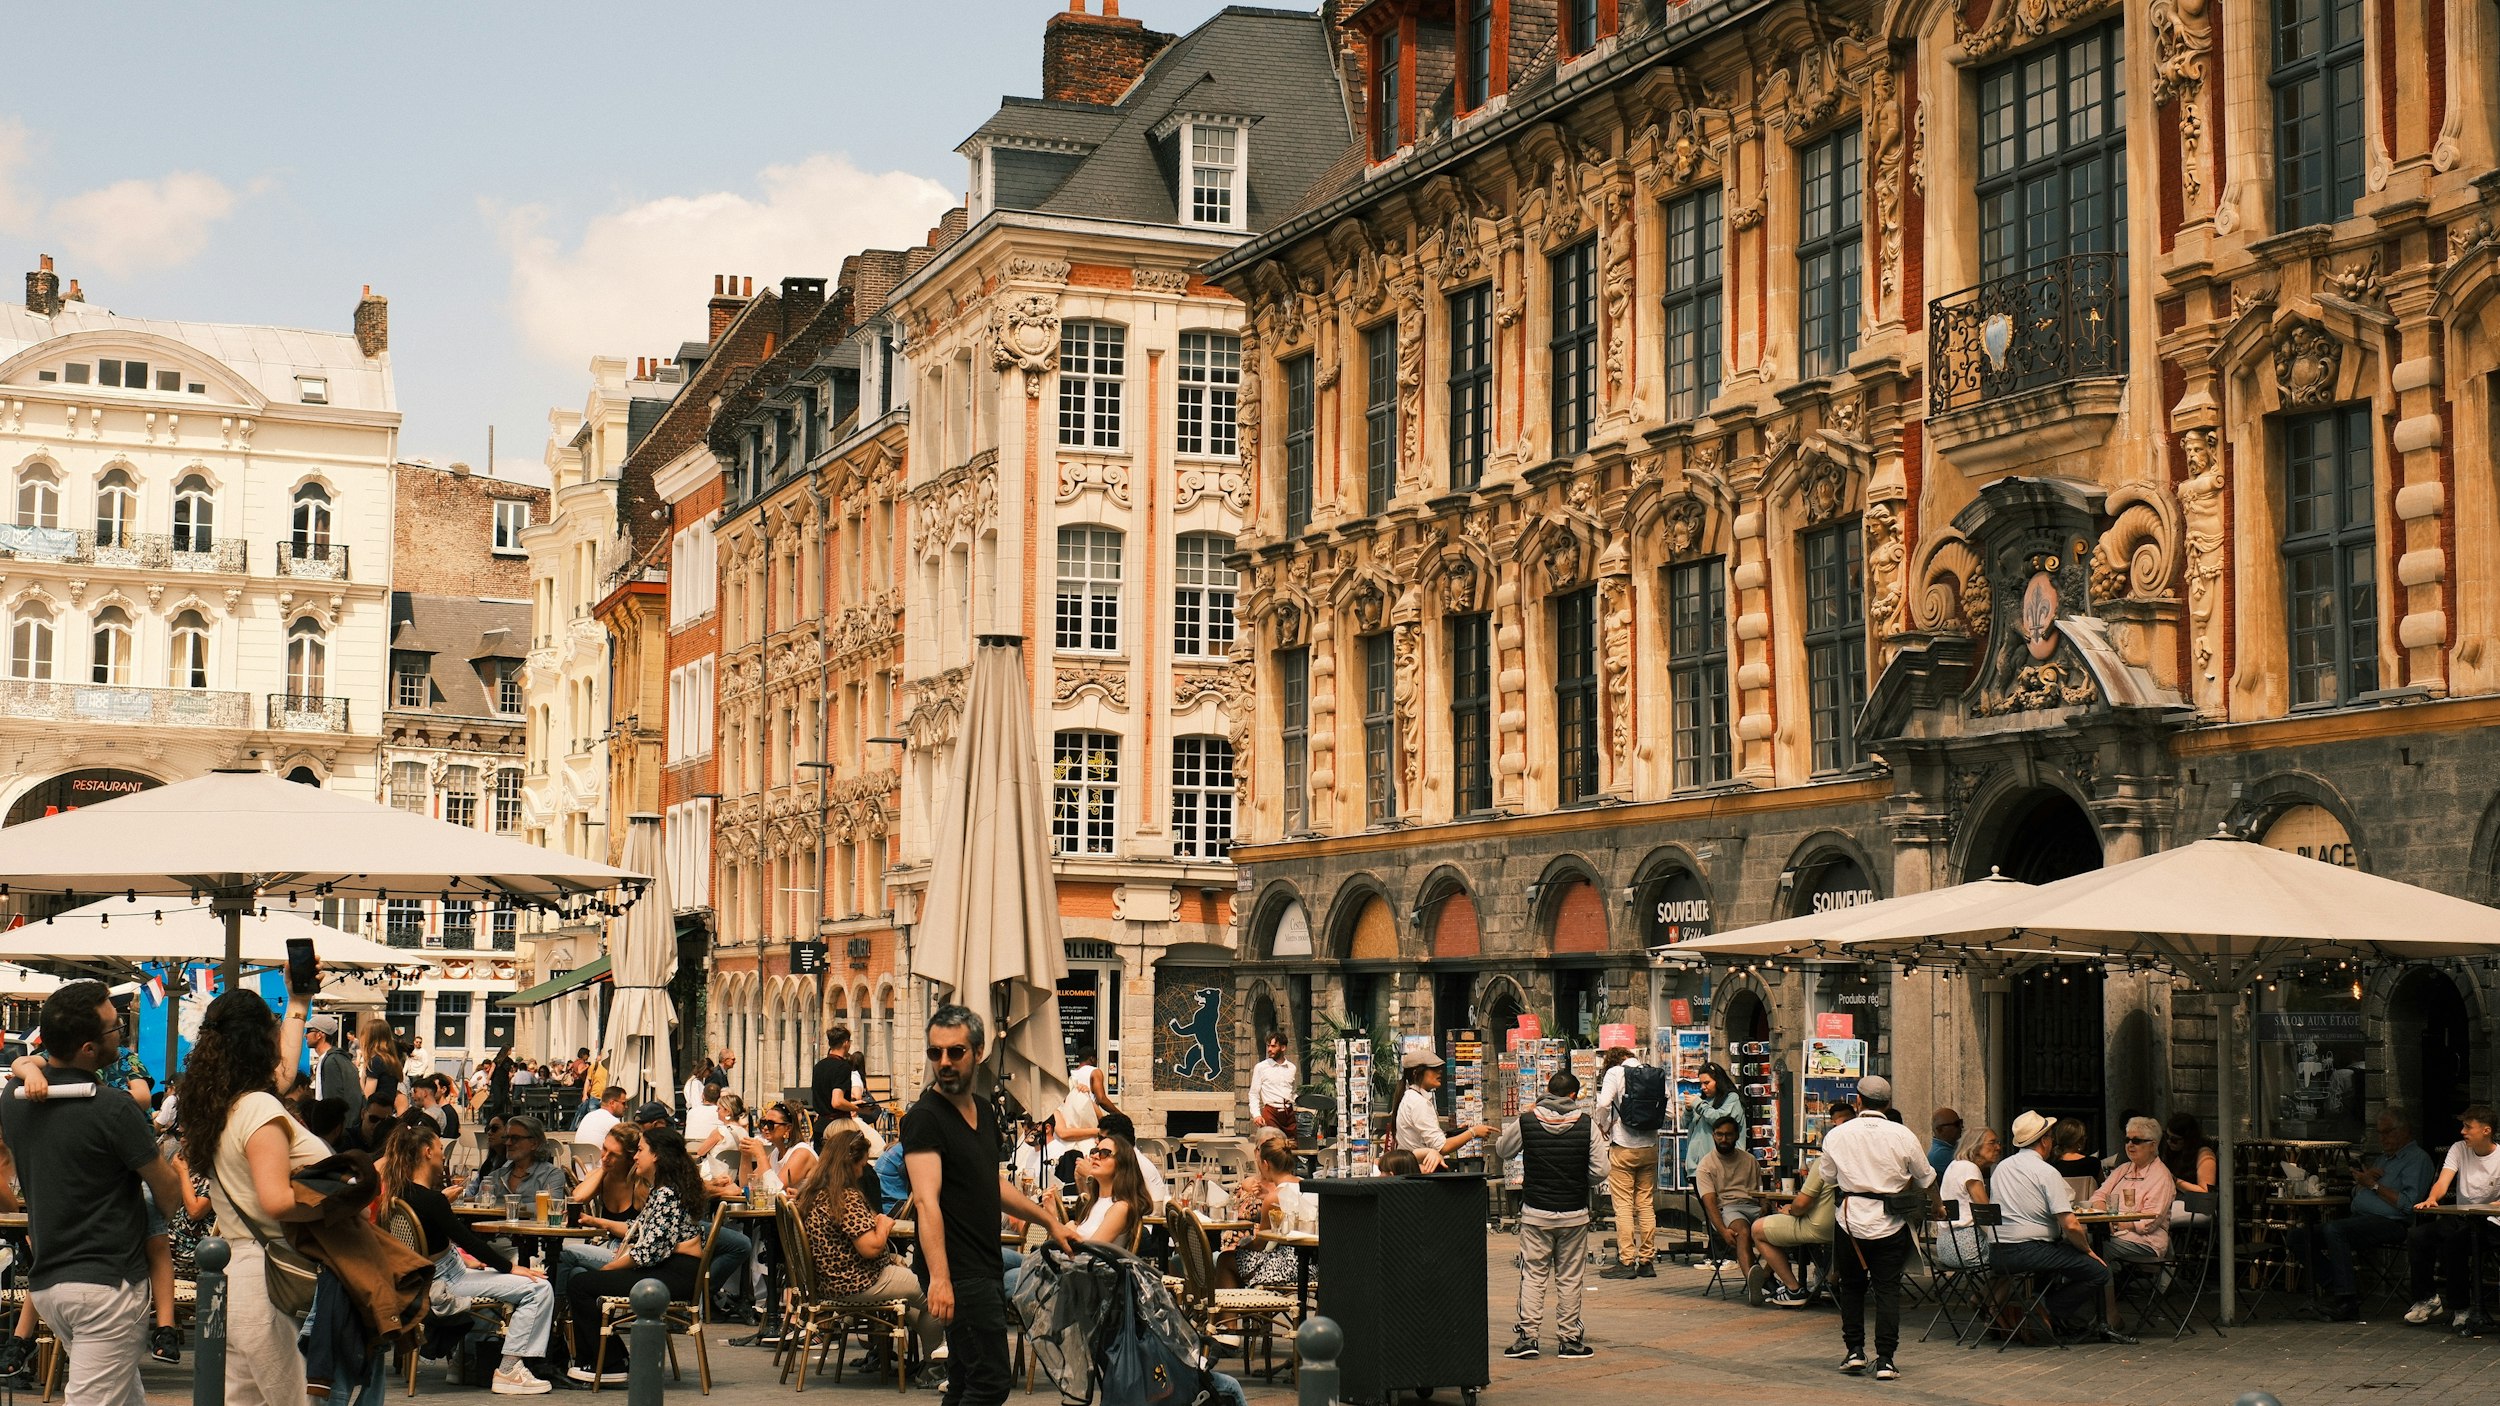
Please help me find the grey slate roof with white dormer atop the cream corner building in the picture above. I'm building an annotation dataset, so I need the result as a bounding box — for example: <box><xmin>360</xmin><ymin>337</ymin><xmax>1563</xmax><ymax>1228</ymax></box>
<box><xmin>965</xmin><ymin>5</ymin><xmax>1355</xmax><ymax>230</ymax></box>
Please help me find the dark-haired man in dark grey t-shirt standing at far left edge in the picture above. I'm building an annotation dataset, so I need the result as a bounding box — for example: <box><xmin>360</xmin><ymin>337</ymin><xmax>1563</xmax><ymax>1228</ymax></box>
<box><xmin>0</xmin><ymin>981</ymin><xmax>183</xmax><ymax>1406</ymax></box>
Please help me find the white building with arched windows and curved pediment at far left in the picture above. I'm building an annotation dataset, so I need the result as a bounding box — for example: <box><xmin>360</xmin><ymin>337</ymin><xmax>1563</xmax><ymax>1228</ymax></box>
<box><xmin>0</xmin><ymin>258</ymin><xmax>400</xmax><ymax>875</ymax></box>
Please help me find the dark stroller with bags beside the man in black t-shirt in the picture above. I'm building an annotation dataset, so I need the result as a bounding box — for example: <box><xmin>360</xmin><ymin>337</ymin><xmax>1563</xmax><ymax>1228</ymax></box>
<box><xmin>1015</xmin><ymin>1241</ymin><xmax>1243</xmax><ymax>1406</ymax></box>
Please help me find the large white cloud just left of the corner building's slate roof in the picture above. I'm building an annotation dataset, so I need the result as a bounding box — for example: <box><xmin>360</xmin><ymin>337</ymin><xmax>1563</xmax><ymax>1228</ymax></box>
<box><xmin>488</xmin><ymin>155</ymin><xmax>955</xmax><ymax>370</ymax></box>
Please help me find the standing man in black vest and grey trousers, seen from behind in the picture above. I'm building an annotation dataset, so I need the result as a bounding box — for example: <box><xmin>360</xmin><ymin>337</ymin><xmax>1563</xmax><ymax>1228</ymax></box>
<box><xmin>1495</xmin><ymin>1068</ymin><xmax>1608</xmax><ymax>1358</ymax></box>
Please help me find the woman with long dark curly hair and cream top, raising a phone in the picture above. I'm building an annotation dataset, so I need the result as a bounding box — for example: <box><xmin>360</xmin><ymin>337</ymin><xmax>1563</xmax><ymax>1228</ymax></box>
<box><xmin>183</xmin><ymin>991</ymin><xmax>330</xmax><ymax>1406</ymax></box>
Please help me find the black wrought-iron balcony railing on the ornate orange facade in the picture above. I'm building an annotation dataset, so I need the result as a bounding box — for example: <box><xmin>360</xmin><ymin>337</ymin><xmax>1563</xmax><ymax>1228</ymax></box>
<box><xmin>1928</xmin><ymin>253</ymin><xmax>2128</xmax><ymax>415</ymax></box>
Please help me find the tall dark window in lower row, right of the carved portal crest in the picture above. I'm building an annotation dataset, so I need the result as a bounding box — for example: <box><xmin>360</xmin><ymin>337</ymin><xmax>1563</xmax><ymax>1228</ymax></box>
<box><xmin>2283</xmin><ymin>405</ymin><xmax>2378</xmax><ymax>706</ymax></box>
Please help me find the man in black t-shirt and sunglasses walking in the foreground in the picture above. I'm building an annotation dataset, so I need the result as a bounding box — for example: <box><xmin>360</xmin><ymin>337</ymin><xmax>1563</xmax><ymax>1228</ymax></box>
<box><xmin>903</xmin><ymin>1006</ymin><xmax>1070</xmax><ymax>1406</ymax></box>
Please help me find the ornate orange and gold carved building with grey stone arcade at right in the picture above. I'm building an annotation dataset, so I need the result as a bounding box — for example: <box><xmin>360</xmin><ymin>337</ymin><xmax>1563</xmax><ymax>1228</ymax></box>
<box><xmin>1208</xmin><ymin>0</ymin><xmax>2500</xmax><ymax>1141</ymax></box>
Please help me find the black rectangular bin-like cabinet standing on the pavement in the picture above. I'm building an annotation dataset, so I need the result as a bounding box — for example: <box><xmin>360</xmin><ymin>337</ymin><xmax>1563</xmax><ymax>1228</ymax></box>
<box><xmin>1303</xmin><ymin>1173</ymin><xmax>1493</xmax><ymax>1403</ymax></box>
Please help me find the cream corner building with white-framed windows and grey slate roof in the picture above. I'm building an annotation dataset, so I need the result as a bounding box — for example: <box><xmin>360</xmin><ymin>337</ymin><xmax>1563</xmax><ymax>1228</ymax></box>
<box><xmin>890</xmin><ymin>5</ymin><xmax>1350</xmax><ymax>1136</ymax></box>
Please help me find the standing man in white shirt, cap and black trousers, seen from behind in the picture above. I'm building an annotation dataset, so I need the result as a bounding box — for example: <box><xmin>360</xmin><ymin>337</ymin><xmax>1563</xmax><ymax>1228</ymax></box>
<box><xmin>1823</xmin><ymin>1073</ymin><xmax>1935</xmax><ymax>1381</ymax></box>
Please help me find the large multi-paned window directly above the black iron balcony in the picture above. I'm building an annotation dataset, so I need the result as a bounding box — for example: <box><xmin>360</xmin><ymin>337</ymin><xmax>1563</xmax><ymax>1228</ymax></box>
<box><xmin>1980</xmin><ymin>23</ymin><xmax>2128</xmax><ymax>280</ymax></box>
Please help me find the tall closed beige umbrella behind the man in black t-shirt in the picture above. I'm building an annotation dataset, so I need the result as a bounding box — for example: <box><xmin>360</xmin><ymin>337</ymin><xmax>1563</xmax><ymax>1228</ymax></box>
<box><xmin>913</xmin><ymin>635</ymin><xmax>1068</xmax><ymax>1113</ymax></box>
